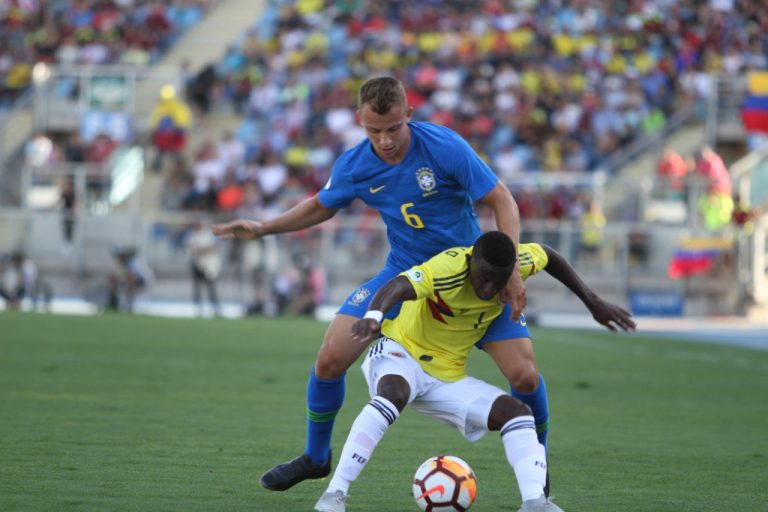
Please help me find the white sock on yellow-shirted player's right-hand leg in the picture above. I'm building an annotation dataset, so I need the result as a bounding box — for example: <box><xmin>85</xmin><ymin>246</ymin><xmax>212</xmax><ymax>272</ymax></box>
<box><xmin>501</xmin><ymin>416</ymin><xmax>547</xmax><ymax>501</ymax></box>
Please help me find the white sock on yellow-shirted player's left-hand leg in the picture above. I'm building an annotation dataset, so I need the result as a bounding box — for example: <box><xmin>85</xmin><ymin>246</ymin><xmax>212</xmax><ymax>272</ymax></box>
<box><xmin>328</xmin><ymin>396</ymin><xmax>400</xmax><ymax>495</ymax></box>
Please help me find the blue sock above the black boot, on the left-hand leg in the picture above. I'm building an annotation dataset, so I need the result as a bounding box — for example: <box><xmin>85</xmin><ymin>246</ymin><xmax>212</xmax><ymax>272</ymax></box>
<box><xmin>304</xmin><ymin>368</ymin><xmax>344</xmax><ymax>464</ymax></box>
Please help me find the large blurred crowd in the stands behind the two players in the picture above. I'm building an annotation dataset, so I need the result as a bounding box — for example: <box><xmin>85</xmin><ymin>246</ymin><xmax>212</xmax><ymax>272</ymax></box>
<box><xmin>152</xmin><ymin>0</ymin><xmax>768</xmax><ymax>219</ymax></box>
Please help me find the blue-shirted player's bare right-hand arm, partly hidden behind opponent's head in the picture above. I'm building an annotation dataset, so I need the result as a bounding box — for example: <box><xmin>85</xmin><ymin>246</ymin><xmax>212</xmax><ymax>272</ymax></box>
<box><xmin>482</xmin><ymin>182</ymin><xmax>526</xmax><ymax>320</ymax></box>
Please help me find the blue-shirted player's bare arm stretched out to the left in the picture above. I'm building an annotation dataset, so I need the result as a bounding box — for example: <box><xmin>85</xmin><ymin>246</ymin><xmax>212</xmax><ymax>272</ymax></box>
<box><xmin>213</xmin><ymin>196</ymin><xmax>338</xmax><ymax>240</ymax></box>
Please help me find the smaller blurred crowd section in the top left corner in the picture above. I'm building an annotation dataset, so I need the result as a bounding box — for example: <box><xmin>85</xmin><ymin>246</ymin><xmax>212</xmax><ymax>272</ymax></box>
<box><xmin>0</xmin><ymin>0</ymin><xmax>212</xmax><ymax>109</ymax></box>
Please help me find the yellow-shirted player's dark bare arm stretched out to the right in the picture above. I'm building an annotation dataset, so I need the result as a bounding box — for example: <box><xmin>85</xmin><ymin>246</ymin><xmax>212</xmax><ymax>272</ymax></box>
<box><xmin>541</xmin><ymin>245</ymin><xmax>637</xmax><ymax>332</ymax></box>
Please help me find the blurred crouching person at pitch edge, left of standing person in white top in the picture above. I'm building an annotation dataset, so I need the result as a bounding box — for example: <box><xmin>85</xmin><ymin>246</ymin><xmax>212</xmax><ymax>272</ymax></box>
<box><xmin>106</xmin><ymin>247</ymin><xmax>152</xmax><ymax>313</ymax></box>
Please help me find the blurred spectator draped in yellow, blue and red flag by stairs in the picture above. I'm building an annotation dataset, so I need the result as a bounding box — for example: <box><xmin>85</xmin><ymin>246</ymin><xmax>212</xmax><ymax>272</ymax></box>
<box><xmin>149</xmin><ymin>85</ymin><xmax>192</xmax><ymax>172</ymax></box>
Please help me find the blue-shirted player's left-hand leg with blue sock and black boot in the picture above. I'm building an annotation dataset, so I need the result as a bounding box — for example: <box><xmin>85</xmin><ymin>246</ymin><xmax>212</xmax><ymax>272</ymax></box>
<box><xmin>261</xmin><ymin>315</ymin><xmax>366</xmax><ymax>491</ymax></box>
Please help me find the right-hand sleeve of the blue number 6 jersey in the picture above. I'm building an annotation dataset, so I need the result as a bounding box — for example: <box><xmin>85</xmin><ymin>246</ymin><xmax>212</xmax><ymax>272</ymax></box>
<box><xmin>435</xmin><ymin>128</ymin><xmax>499</xmax><ymax>201</ymax></box>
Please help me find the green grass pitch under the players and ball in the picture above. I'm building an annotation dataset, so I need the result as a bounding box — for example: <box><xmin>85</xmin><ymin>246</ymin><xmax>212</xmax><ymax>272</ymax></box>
<box><xmin>0</xmin><ymin>313</ymin><xmax>768</xmax><ymax>512</ymax></box>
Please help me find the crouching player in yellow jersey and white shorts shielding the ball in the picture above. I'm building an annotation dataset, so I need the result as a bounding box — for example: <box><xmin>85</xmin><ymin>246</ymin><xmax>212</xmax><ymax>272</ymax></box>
<box><xmin>315</xmin><ymin>231</ymin><xmax>635</xmax><ymax>512</ymax></box>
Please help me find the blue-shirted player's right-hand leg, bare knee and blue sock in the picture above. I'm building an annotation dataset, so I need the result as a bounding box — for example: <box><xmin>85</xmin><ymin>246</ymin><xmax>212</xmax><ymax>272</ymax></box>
<box><xmin>482</xmin><ymin>338</ymin><xmax>549</xmax><ymax>447</ymax></box>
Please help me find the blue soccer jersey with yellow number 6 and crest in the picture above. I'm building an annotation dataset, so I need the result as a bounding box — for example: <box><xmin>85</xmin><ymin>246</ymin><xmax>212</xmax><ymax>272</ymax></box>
<box><xmin>318</xmin><ymin>122</ymin><xmax>498</xmax><ymax>270</ymax></box>
